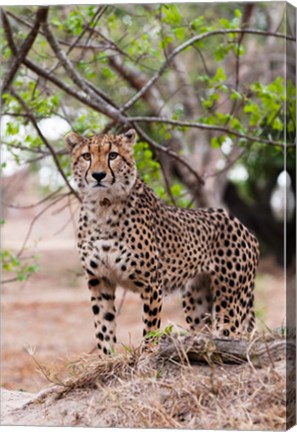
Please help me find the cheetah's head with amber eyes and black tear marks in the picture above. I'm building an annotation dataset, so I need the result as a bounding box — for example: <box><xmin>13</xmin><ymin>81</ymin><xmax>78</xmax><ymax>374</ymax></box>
<box><xmin>65</xmin><ymin>129</ymin><xmax>137</xmax><ymax>198</ymax></box>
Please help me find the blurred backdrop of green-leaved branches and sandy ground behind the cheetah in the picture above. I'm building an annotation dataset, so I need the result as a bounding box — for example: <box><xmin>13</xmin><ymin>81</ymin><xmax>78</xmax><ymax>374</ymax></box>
<box><xmin>1</xmin><ymin>2</ymin><xmax>296</xmax><ymax>390</ymax></box>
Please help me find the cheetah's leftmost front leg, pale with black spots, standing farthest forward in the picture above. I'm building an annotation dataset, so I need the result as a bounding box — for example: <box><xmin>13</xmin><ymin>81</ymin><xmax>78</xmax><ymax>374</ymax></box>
<box><xmin>88</xmin><ymin>276</ymin><xmax>116</xmax><ymax>355</ymax></box>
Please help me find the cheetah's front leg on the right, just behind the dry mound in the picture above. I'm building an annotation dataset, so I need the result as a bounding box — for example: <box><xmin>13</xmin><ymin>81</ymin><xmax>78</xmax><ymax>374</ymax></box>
<box><xmin>141</xmin><ymin>284</ymin><xmax>162</xmax><ymax>340</ymax></box>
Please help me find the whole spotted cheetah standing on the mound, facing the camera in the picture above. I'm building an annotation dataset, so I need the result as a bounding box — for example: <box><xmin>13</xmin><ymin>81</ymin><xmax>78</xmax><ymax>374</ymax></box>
<box><xmin>65</xmin><ymin>129</ymin><xmax>259</xmax><ymax>355</ymax></box>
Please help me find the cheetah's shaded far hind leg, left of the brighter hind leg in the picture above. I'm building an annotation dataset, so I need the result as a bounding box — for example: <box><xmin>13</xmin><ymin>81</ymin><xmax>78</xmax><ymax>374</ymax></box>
<box><xmin>182</xmin><ymin>273</ymin><xmax>212</xmax><ymax>331</ymax></box>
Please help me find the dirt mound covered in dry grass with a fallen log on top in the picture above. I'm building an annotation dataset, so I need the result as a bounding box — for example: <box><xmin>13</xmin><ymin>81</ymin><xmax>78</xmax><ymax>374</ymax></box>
<box><xmin>1</xmin><ymin>334</ymin><xmax>294</xmax><ymax>430</ymax></box>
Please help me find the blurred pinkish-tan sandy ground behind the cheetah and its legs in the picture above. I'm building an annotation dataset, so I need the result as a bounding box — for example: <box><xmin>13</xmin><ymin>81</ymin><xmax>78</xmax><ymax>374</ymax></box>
<box><xmin>1</xmin><ymin>175</ymin><xmax>285</xmax><ymax>392</ymax></box>
